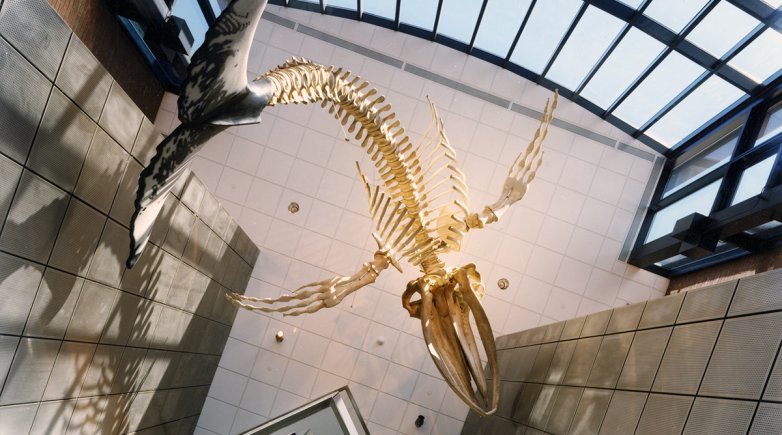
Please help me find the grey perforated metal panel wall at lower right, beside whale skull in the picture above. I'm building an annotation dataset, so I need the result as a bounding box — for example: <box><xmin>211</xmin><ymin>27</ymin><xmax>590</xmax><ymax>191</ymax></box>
<box><xmin>466</xmin><ymin>269</ymin><xmax>782</xmax><ymax>435</ymax></box>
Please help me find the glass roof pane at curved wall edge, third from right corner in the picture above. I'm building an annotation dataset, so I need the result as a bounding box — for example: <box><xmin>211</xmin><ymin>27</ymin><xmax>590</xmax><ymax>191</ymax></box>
<box><xmin>581</xmin><ymin>28</ymin><xmax>665</xmax><ymax>109</ymax></box>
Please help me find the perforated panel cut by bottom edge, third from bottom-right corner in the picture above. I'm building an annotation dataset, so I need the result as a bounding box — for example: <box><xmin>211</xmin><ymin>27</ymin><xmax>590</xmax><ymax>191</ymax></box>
<box><xmin>635</xmin><ymin>394</ymin><xmax>693</xmax><ymax>435</ymax></box>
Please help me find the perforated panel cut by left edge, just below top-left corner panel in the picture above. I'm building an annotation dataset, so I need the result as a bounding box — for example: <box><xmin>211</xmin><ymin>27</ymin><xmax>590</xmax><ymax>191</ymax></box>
<box><xmin>0</xmin><ymin>38</ymin><xmax>52</xmax><ymax>163</ymax></box>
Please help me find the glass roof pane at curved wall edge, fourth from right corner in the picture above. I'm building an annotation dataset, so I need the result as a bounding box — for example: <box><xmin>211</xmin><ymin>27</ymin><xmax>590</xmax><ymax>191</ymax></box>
<box><xmin>546</xmin><ymin>6</ymin><xmax>625</xmax><ymax>90</ymax></box>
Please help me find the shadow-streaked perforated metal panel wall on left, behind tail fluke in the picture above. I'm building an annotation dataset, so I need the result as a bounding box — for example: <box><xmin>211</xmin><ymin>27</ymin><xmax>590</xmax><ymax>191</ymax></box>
<box><xmin>0</xmin><ymin>0</ymin><xmax>258</xmax><ymax>434</ymax></box>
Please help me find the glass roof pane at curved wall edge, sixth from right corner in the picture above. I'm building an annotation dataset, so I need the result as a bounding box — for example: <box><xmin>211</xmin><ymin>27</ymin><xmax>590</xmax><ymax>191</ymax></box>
<box><xmin>475</xmin><ymin>0</ymin><xmax>532</xmax><ymax>58</ymax></box>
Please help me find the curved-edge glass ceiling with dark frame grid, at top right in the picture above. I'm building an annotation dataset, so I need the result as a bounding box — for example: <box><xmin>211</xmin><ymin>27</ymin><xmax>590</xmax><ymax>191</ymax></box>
<box><xmin>270</xmin><ymin>0</ymin><xmax>782</xmax><ymax>153</ymax></box>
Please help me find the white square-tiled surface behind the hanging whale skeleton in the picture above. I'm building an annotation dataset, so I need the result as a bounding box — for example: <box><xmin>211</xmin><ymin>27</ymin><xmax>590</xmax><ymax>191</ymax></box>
<box><xmin>157</xmin><ymin>6</ymin><xmax>667</xmax><ymax>434</ymax></box>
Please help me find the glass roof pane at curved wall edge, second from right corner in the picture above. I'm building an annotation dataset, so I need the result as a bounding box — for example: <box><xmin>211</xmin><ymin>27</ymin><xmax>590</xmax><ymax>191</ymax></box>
<box><xmin>614</xmin><ymin>52</ymin><xmax>706</xmax><ymax>128</ymax></box>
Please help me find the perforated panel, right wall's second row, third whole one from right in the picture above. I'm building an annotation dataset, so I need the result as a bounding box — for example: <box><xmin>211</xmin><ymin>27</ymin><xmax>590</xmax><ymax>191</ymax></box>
<box><xmin>617</xmin><ymin>327</ymin><xmax>673</xmax><ymax>391</ymax></box>
